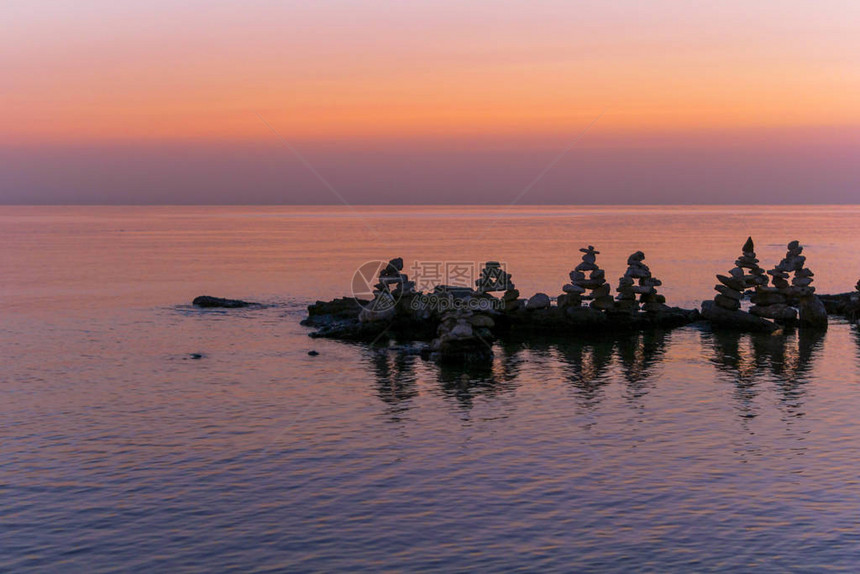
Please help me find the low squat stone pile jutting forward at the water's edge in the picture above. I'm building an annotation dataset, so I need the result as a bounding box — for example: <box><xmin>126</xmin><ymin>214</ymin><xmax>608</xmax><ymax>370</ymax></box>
<box><xmin>430</xmin><ymin>309</ymin><xmax>494</xmax><ymax>363</ymax></box>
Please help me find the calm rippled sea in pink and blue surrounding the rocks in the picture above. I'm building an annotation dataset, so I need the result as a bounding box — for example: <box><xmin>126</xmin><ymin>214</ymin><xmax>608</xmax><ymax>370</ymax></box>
<box><xmin>0</xmin><ymin>206</ymin><xmax>860</xmax><ymax>572</ymax></box>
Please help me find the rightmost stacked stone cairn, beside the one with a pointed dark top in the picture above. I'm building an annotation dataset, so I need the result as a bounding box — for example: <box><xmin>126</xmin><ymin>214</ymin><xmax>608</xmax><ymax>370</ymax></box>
<box><xmin>750</xmin><ymin>241</ymin><xmax>815</xmax><ymax>323</ymax></box>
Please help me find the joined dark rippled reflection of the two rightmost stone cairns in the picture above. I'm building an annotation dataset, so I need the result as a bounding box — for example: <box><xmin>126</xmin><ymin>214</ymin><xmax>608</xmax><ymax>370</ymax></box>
<box><xmin>703</xmin><ymin>329</ymin><xmax>826</xmax><ymax>418</ymax></box>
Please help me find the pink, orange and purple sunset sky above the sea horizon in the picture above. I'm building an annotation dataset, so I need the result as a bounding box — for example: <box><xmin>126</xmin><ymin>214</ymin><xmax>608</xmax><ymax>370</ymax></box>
<box><xmin>0</xmin><ymin>0</ymin><xmax>860</xmax><ymax>204</ymax></box>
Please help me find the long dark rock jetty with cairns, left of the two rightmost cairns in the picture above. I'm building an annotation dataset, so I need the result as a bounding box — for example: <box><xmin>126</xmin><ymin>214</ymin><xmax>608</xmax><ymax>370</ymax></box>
<box><xmin>303</xmin><ymin>252</ymin><xmax>699</xmax><ymax>362</ymax></box>
